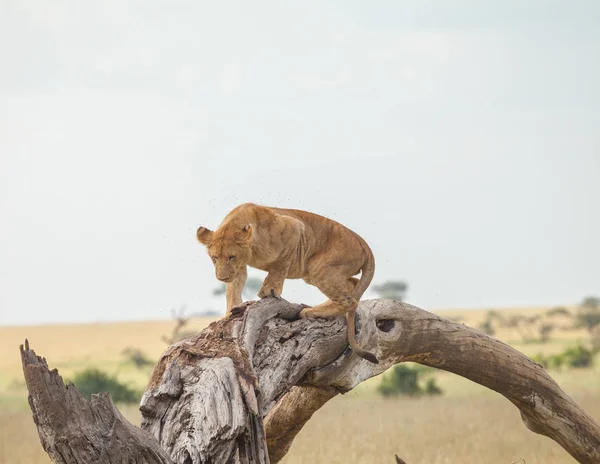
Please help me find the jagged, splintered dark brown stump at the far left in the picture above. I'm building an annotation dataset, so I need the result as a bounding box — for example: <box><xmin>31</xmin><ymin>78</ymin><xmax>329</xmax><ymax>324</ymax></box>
<box><xmin>20</xmin><ymin>340</ymin><xmax>173</xmax><ymax>464</ymax></box>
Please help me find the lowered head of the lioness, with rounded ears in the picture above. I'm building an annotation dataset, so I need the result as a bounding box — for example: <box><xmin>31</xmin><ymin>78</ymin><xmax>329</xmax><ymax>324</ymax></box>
<box><xmin>196</xmin><ymin>224</ymin><xmax>252</xmax><ymax>282</ymax></box>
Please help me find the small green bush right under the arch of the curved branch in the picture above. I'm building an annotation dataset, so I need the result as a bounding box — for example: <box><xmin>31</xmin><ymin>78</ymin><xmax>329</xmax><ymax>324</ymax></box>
<box><xmin>377</xmin><ymin>364</ymin><xmax>442</xmax><ymax>396</ymax></box>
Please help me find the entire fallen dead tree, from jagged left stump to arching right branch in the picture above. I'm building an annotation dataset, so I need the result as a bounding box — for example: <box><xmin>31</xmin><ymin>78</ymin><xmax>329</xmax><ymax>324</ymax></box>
<box><xmin>22</xmin><ymin>298</ymin><xmax>600</xmax><ymax>464</ymax></box>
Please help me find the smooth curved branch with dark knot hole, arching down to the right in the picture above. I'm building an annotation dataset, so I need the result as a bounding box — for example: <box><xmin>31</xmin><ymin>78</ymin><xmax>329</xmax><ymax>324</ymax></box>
<box><xmin>309</xmin><ymin>300</ymin><xmax>600</xmax><ymax>464</ymax></box>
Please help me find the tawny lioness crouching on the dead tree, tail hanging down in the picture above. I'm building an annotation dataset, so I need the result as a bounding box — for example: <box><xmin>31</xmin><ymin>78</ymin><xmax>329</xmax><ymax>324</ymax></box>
<box><xmin>196</xmin><ymin>203</ymin><xmax>378</xmax><ymax>363</ymax></box>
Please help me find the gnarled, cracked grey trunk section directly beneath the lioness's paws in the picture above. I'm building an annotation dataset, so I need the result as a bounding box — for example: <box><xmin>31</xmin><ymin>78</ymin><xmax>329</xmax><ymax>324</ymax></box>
<box><xmin>140</xmin><ymin>298</ymin><xmax>347</xmax><ymax>464</ymax></box>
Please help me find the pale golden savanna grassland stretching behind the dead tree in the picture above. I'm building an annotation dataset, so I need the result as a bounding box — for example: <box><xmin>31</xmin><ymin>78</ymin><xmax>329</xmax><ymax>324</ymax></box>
<box><xmin>0</xmin><ymin>308</ymin><xmax>600</xmax><ymax>464</ymax></box>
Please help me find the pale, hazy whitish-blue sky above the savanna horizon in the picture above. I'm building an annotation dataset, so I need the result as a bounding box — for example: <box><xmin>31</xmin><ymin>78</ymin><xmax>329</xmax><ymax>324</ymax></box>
<box><xmin>0</xmin><ymin>0</ymin><xmax>600</xmax><ymax>325</ymax></box>
